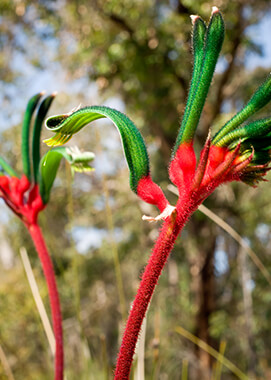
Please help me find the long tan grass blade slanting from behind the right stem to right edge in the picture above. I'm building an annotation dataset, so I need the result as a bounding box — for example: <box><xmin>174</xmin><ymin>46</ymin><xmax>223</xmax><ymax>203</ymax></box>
<box><xmin>168</xmin><ymin>185</ymin><xmax>271</xmax><ymax>286</ymax></box>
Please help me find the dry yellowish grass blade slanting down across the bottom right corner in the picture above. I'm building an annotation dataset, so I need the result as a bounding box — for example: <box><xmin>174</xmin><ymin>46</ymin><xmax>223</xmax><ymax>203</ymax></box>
<box><xmin>175</xmin><ymin>326</ymin><xmax>249</xmax><ymax>380</ymax></box>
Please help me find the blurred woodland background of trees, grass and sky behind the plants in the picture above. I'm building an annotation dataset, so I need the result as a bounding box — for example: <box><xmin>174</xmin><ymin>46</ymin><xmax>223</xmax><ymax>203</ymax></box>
<box><xmin>0</xmin><ymin>0</ymin><xmax>271</xmax><ymax>380</ymax></box>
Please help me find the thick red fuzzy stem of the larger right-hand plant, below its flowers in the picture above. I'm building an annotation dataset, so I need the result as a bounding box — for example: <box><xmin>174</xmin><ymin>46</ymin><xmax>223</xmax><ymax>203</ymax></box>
<box><xmin>114</xmin><ymin>196</ymin><xmax>199</xmax><ymax>380</ymax></box>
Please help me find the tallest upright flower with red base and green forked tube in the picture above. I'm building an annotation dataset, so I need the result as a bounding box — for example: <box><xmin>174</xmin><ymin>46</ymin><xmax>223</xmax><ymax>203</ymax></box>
<box><xmin>169</xmin><ymin>7</ymin><xmax>224</xmax><ymax>191</ymax></box>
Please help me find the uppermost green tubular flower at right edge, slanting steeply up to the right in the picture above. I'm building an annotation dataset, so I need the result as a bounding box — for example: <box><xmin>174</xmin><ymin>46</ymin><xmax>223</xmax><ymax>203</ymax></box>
<box><xmin>215</xmin><ymin>75</ymin><xmax>271</xmax><ymax>145</ymax></box>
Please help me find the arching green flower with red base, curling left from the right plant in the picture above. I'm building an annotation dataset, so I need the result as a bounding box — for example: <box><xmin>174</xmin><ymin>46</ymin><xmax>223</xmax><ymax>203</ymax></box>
<box><xmin>45</xmin><ymin>106</ymin><xmax>171</xmax><ymax>211</ymax></box>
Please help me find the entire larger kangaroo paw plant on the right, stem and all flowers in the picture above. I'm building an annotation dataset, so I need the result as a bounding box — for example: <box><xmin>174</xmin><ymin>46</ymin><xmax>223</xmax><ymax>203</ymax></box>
<box><xmin>46</xmin><ymin>7</ymin><xmax>271</xmax><ymax>380</ymax></box>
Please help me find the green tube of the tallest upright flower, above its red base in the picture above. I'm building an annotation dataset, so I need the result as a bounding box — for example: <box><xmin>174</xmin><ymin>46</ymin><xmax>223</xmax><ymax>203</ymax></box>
<box><xmin>173</xmin><ymin>10</ymin><xmax>224</xmax><ymax>153</ymax></box>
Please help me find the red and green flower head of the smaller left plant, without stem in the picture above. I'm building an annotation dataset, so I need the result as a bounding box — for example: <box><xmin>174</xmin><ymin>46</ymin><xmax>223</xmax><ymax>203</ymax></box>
<box><xmin>0</xmin><ymin>93</ymin><xmax>94</xmax><ymax>225</ymax></box>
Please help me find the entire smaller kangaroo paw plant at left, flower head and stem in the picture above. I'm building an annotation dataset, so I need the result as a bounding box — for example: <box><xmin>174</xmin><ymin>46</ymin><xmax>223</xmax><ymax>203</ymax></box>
<box><xmin>0</xmin><ymin>93</ymin><xmax>94</xmax><ymax>380</ymax></box>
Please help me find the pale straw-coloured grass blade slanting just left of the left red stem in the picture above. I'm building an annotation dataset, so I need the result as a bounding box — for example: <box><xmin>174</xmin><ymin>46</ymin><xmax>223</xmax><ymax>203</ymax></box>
<box><xmin>20</xmin><ymin>247</ymin><xmax>55</xmax><ymax>355</ymax></box>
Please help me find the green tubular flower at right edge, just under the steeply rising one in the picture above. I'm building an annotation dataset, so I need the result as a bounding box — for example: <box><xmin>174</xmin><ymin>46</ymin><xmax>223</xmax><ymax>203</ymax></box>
<box><xmin>215</xmin><ymin>117</ymin><xmax>271</xmax><ymax>146</ymax></box>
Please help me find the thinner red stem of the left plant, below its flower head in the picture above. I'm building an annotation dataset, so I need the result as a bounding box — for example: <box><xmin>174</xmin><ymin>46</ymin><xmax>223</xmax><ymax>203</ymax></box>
<box><xmin>27</xmin><ymin>224</ymin><xmax>64</xmax><ymax>380</ymax></box>
